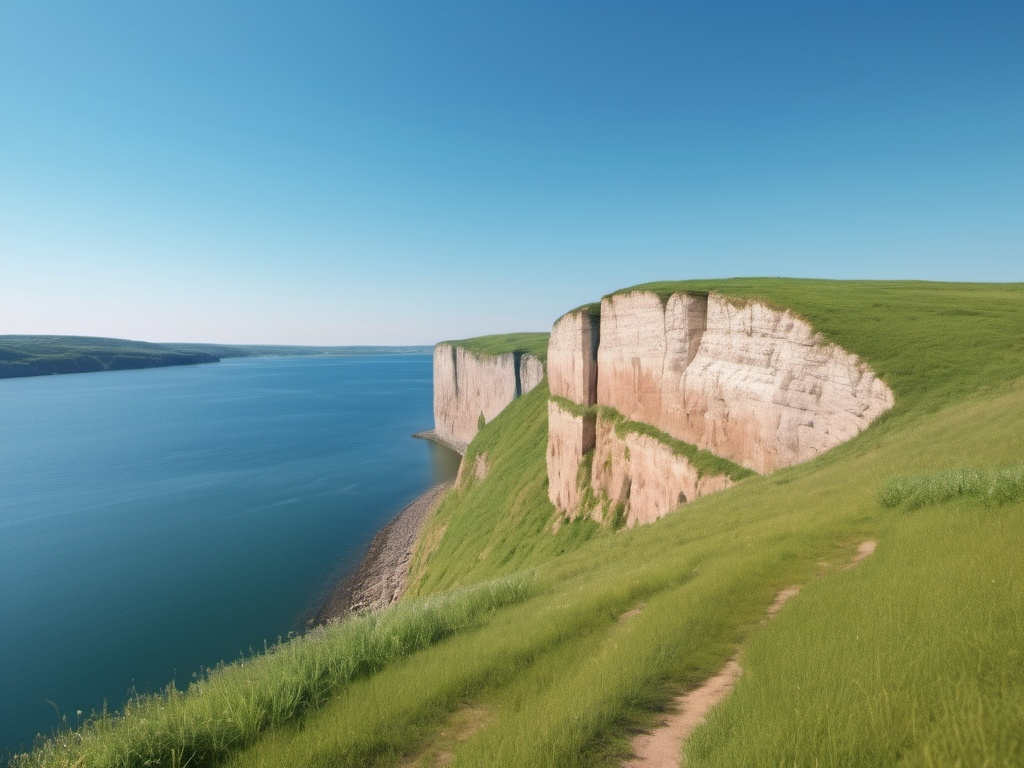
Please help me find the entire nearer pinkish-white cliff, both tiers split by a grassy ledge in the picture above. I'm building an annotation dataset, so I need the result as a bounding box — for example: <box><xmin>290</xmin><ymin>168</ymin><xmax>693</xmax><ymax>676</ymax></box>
<box><xmin>548</xmin><ymin>292</ymin><xmax>893</xmax><ymax>524</ymax></box>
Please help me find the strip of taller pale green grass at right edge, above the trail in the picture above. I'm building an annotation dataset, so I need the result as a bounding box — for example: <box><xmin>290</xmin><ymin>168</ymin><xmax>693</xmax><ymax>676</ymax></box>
<box><xmin>879</xmin><ymin>464</ymin><xmax>1024</xmax><ymax>509</ymax></box>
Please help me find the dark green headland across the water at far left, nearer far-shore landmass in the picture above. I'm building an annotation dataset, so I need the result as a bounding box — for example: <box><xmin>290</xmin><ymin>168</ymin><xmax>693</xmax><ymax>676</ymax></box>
<box><xmin>0</xmin><ymin>336</ymin><xmax>217</xmax><ymax>378</ymax></box>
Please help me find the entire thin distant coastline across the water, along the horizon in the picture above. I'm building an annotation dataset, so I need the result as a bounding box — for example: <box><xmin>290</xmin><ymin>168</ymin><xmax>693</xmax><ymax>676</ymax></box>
<box><xmin>0</xmin><ymin>336</ymin><xmax>432</xmax><ymax>379</ymax></box>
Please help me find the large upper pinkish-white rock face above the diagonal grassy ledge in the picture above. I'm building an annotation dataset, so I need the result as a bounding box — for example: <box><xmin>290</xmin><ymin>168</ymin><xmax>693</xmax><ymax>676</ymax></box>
<box><xmin>597</xmin><ymin>292</ymin><xmax>893</xmax><ymax>473</ymax></box>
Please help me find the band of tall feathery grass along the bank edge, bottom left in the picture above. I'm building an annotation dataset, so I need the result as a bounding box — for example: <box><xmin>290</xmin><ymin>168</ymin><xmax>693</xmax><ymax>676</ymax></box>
<box><xmin>12</xmin><ymin>575</ymin><xmax>532</xmax><ymax>768</ymax></box>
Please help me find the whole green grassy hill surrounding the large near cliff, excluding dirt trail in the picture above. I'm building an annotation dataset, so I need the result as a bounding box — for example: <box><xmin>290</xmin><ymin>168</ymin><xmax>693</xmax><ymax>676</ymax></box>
<box><xmin>17</xmin><ymin>280</ymin><xmax>1024</xmax><ymax>768</ymax></box>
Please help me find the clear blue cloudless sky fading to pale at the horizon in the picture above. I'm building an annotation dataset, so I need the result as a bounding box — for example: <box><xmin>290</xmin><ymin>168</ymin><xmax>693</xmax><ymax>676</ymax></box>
<box><xmin>0</xmin><ymin>0</ymin><xmax>1024</xmax><ymax>344</ymax></box>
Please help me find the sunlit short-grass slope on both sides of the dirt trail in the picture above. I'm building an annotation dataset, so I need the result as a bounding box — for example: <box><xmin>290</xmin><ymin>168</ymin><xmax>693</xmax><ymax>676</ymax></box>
<box><xmin>228</xmin><ymin>387</ymin><xmax>1024</xmax><ymax>767</ymax></box>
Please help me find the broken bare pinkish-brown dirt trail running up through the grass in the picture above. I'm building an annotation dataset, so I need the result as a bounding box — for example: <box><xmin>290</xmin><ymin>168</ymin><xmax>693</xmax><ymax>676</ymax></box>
<box><xmin>623</xmin><ymin>541</ymin><xmax>878</xmax><ymax>768</ymax></box>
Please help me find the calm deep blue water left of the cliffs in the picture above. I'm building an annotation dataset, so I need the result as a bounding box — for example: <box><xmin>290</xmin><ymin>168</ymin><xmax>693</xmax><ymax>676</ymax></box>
<box><xmin>0</xmin><ymin>355</ymin><xmax>458</xmax><ymax>755</ymax></box>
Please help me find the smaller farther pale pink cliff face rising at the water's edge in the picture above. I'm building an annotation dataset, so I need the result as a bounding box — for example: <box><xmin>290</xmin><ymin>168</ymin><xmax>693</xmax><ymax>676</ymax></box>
<box><xmin>434</xmin><ymin>344</ymin><xmax>544</xmax><ymax>449</ymax></box>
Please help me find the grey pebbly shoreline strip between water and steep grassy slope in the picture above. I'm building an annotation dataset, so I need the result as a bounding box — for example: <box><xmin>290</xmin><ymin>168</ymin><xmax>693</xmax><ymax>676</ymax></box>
<box><xmin>306</xmin><ymin>481</ymin><xmax>455</xmax><ymax>629</ymax></box>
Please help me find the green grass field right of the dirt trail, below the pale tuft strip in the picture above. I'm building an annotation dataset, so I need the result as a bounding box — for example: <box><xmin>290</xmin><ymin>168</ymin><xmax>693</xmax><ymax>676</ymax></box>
<box><xmin>686</xmin><ymin>505</ymin><xmax>1024</xmax><ymax>768</ymax></box>
